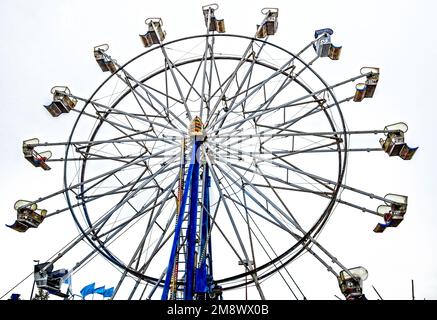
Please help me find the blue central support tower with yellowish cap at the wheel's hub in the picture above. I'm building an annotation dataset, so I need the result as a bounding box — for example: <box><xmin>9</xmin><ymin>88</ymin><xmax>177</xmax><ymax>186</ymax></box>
<box><xmin>161</xmin><ymin>117</ymin><xmax>213</xmax><ymax>300</ymax></box>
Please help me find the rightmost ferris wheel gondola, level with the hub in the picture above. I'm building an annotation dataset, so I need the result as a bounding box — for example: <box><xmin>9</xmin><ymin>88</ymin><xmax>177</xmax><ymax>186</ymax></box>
<box><xmin>379</xmin><ymin>122</ymin><xmax>418</xmax><ymax>160</ymax></box>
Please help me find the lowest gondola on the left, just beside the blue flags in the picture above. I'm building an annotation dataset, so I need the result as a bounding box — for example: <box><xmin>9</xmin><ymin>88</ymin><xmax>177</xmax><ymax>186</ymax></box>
<box><xmin>34</xmin><ymin>262</ymin><xmax>70</xmax><ymax>298</ymax></box>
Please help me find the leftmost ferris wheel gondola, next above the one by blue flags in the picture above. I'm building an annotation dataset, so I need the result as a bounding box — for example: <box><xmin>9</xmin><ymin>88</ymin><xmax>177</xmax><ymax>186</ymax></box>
<box><xmin>6</xmin><ymin>200</ymin><xmax>47</xmax><ymax>232</ymax></box>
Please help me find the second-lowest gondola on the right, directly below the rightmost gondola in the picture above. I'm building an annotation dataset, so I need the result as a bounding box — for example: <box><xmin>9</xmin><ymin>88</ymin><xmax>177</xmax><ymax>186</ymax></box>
<box><xmin>373</xmin><ymin>193</ymin><xmax>408</xmax><ymax>233</ymax></box>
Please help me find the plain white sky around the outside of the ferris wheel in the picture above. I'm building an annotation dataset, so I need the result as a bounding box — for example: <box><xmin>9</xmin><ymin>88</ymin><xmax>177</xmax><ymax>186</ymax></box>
<box><xmin>0</xmin><ymin>0</ymin><xmax>437</xmax><ymax>299</ymax></box>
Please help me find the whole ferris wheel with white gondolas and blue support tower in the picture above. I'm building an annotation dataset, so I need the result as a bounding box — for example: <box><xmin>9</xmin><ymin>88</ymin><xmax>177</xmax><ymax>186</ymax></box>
<box><xmin>5</xmin><ymin>4</ymin><xmax>417</xmax><ymax>300</ymax></box>
